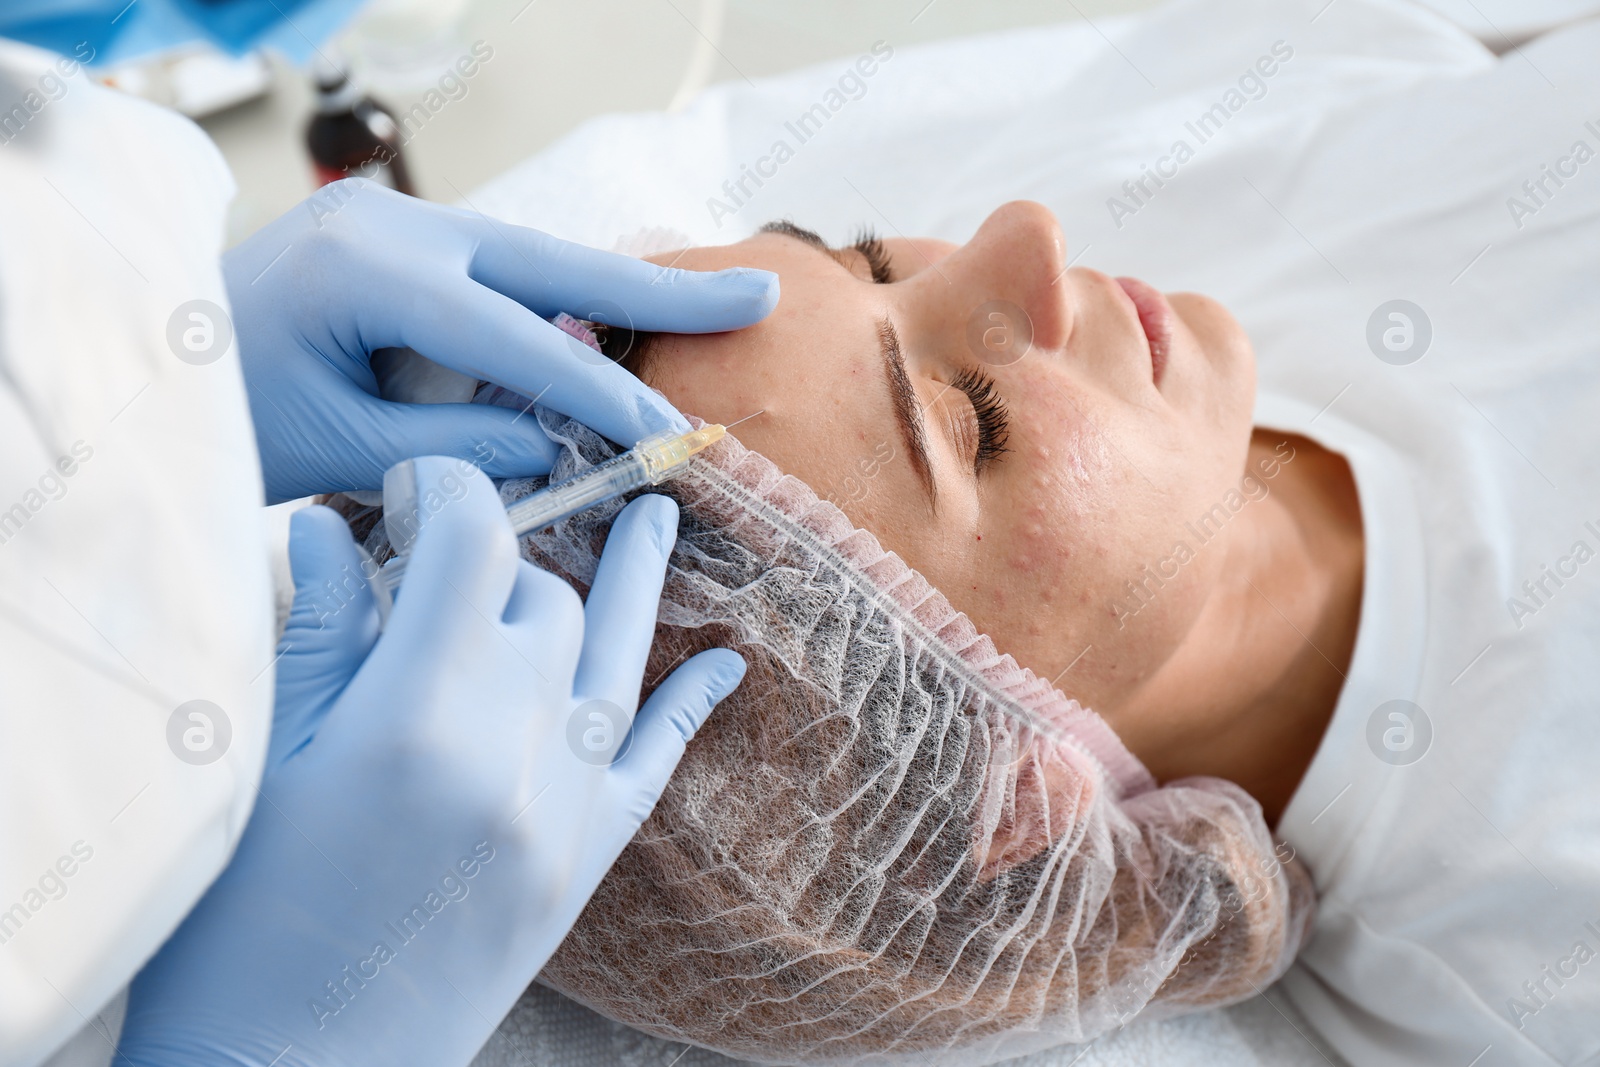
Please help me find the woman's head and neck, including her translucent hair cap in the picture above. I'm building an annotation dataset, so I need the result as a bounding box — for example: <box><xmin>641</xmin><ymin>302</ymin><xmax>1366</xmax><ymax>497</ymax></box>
<box><xmin>346</xmin><ymin>203</ymin><xmax>1344</xmax><ymax>1064</ymax></box>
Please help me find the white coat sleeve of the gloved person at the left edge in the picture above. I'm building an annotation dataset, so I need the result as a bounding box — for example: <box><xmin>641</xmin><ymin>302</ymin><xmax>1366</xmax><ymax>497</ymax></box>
<box><xmin>0</xmin><ymin>42</ymin><xmax>274</xmax><ymax>1064</ymax></box>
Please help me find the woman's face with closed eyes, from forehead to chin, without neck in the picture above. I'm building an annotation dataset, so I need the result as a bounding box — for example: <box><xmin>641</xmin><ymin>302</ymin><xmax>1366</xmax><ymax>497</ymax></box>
<box><xmin>643</xmin><ymin>202</ymin><xmax>1254</xmax><ymax>710</ymax></box>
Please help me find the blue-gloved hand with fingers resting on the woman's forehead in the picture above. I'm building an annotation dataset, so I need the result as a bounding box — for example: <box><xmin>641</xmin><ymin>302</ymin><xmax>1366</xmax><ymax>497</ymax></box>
<box><xmin>222</xmin><ymin>178</ymin><xmax>778</xmax><ymax>502</ymax></box>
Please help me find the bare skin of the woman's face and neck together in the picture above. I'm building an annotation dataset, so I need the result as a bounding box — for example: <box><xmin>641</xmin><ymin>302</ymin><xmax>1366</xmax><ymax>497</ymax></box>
<box><xmin>638</xmin><ymin>202</ymin><xmax>1363</xmax><ymax>824</ymax></box>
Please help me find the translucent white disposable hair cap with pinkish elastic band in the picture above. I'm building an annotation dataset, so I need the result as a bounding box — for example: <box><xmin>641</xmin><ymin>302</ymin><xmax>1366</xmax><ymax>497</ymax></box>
<box><xmin>340</xmin><ymin>404</ymin><xmax>1314</xmax><ymax>1067</ymax></box>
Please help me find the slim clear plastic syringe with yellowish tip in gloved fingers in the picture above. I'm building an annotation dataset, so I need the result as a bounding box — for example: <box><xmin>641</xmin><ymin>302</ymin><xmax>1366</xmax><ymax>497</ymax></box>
<box><xmin>374</xmin><ymin>422</ymin><xmax>728</xmax><ymax>598</ymax></box>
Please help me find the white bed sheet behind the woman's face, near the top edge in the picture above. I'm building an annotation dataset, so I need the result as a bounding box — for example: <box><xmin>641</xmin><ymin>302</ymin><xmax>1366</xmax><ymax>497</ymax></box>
<box><xmin>467</xmin><ymin>0</ymin><xmax>1494</xmax><ymax>254</ymax></box>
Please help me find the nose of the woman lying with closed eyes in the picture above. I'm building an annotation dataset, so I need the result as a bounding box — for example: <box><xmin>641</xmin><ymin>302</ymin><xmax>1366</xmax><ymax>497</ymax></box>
<box><xmin>939</xmin><ymin>200</ymin><xmax>1072</xmax><ymax>362</ymax></box>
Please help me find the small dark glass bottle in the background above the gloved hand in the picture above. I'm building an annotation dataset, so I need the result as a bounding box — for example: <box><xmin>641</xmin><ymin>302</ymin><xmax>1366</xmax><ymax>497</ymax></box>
<box><xmin>306</xmin><ymin>61</ymin><xmax>416</xmax><ymax>197</ymax></box>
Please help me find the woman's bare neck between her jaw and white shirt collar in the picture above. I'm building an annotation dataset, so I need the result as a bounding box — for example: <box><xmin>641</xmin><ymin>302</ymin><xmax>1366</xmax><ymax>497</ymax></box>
<box><xmin>1107</xmin><ymin>430</ymin><xmax>1365</xmax><ymax>824</ymax></box>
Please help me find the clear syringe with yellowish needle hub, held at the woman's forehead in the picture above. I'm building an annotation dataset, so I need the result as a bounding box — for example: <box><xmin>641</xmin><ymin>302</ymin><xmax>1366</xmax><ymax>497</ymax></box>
<box><xmin>378</xmin><ymin>422</ymin><xmax>728</xmax><ymax>593</ymax></box>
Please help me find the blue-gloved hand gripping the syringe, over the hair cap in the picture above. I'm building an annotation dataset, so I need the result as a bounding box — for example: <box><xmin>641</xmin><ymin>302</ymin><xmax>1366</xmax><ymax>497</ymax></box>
<box><xmin>117</xmin><ymin>458</ymin><xmax>744</xmax><ymax>1067</ymax></box>
